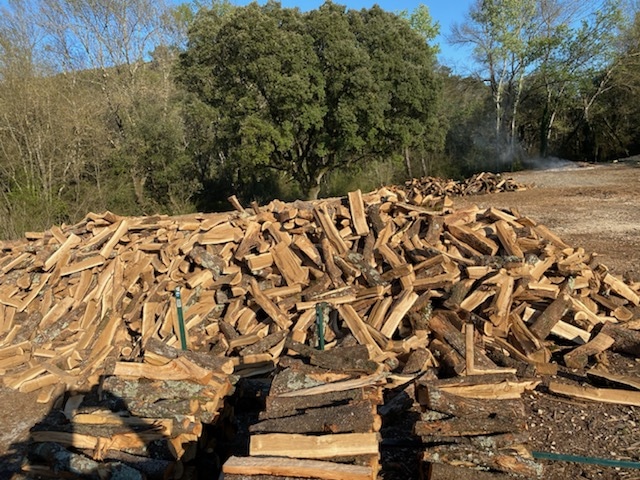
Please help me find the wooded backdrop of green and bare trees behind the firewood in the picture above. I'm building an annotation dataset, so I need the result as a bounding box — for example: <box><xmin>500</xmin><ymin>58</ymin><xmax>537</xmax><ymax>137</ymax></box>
<box><xmin>0</xmin><ymin>0</ymin><xmax>640</xmax><ymax>239</ymax></box>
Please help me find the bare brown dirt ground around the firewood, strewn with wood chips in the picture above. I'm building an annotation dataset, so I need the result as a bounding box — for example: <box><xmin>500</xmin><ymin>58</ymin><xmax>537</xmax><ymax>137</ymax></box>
<box><xmin>0</xmin><ymin>159</ymin><xmax>640</xmax><ymax>480</ymax></box>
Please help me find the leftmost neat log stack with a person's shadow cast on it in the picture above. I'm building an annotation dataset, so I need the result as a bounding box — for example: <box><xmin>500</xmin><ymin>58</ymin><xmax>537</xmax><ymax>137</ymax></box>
<box><xmin>28</xmin><ymin>338</ymin><xmax>233</xmax><ymax>479</ymax></box>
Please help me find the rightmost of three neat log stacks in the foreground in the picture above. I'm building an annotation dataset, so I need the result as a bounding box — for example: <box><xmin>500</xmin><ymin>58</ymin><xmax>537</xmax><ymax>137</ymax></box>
<box><xmin>415</xmin><ymin>374</ymin><xmax>542</xmax><ymax>479</ymax></box>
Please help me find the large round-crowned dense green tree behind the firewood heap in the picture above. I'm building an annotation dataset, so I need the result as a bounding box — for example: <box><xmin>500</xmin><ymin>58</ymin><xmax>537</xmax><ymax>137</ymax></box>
<box><xmin>179</xmin><ymin>2</ymin><xmax>440</xmax><ymax>198</ymax></box>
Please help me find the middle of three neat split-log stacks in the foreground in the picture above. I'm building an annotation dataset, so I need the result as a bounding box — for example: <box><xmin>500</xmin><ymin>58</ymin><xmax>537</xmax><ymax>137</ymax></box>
<box><xmin>222</xmin><ymin>342</ymin><xmax>384</xmax><ymax>480</ymax></box>
